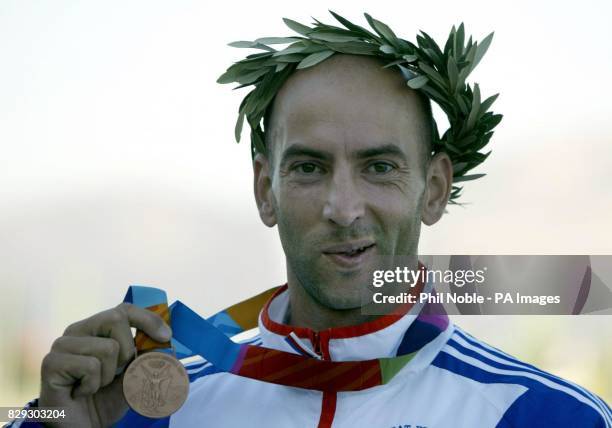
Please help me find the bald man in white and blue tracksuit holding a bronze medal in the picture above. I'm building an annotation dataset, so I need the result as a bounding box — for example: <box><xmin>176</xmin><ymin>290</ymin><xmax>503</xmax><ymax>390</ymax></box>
<box><xmin>15</xmin><ymin>11</ymin><xmax>612</xmax><ymax>428</ymax></box>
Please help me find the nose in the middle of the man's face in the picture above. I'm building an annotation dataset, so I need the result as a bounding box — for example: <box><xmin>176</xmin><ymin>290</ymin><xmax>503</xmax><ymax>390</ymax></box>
<box><xmin>323</xmin><ymin>168</ymin><xmax>365</xmax><ymax>227</ymax></box>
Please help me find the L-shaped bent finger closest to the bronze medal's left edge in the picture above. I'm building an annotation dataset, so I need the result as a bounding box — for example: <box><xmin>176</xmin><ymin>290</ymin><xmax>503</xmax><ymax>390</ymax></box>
<box><xmin>51</xmin><ymin>336</ymin><xmax>120</xmax><ymax>386</ymax></box>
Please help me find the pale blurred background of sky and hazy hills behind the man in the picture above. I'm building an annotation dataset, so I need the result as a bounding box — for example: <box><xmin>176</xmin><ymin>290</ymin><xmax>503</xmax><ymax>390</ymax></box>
<box><xmin>0</xmin><ymin>0</ymin><xmax>612</xmax><ymax>406</ymax></box>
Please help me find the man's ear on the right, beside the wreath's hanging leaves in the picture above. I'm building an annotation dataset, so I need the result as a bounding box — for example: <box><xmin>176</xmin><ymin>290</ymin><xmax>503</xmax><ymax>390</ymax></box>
<box><xmin>421</xmin><ymin>152</ymin><xmax>453</xmax><ymax>226</ymax></box>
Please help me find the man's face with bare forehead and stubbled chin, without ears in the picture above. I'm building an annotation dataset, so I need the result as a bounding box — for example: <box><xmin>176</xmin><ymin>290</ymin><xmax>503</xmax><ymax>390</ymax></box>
<box><xmin>269</xmin><ymin>55</ymin><xmax>436</xmax><ymax>309</ymax></box>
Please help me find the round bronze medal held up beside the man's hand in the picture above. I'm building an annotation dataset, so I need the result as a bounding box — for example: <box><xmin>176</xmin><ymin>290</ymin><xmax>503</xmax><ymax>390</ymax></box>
<box><xmin>123</xmin><ymin>352</ymin><xmax>189</xmax><ymax>418</ymax></box>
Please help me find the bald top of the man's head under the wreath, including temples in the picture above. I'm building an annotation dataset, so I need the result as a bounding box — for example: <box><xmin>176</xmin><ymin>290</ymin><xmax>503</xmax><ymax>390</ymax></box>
<box><xmin>264</xmin><ymin>54</ymin><xmax>432</xmax><ymax>171</ymax></box>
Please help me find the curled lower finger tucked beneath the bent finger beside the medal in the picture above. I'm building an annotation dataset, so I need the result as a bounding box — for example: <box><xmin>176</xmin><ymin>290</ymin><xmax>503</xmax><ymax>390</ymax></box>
<box><xmin>41</xmin><ymin>352</ymin><xmax>102</xmax><ymax>398</ymax></box>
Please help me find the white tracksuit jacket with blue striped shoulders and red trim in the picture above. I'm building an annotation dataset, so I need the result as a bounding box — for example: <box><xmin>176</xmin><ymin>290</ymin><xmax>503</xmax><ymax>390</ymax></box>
<box><xmin>121</xmin><ymin>289</ymin><xmax>612</xmax><ymax>428</ymax></box>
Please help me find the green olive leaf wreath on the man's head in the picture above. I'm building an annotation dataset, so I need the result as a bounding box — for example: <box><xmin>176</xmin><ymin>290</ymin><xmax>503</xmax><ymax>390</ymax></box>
<box><xmin>217</xmin><ymin>11</ymin><xmax>502</xmax><ymax>204</ymax></box>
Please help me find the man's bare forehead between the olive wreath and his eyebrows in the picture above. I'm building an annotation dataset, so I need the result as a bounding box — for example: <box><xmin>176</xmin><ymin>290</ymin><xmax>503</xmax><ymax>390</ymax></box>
<box><xmin>272</xmin><ymin>55</ymin><xmax>426</xmax><ymax>157</ymax></box>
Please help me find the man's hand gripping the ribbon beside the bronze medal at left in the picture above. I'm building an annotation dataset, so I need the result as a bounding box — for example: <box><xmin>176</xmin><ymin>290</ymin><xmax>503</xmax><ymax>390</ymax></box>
<box><xmin>38</xmin><ymin>303</ymin><xmax>172</xmax><ymax>428</ymax></box>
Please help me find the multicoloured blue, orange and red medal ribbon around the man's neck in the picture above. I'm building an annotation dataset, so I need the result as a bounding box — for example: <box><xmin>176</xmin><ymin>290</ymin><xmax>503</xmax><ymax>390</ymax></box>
<box><xmin>124</xmin><ymin>286</ymin><xmax>448</xmax><ymax>392</ymax></box>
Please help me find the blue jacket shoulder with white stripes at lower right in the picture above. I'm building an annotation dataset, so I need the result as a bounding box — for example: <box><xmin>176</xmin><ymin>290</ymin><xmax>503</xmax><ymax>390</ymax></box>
<box><xmin>432</xmin><ymin>326</ymin><xmax>612</xmax><ymax>427</ymax></box>
